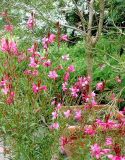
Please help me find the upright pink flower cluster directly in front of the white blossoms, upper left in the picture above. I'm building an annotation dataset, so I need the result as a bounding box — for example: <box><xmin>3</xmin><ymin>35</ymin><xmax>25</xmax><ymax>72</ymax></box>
<box><xmin>27</xmin><ymin>13</ymin><xmax>36</xmax><ymax>29</ymax></box>
